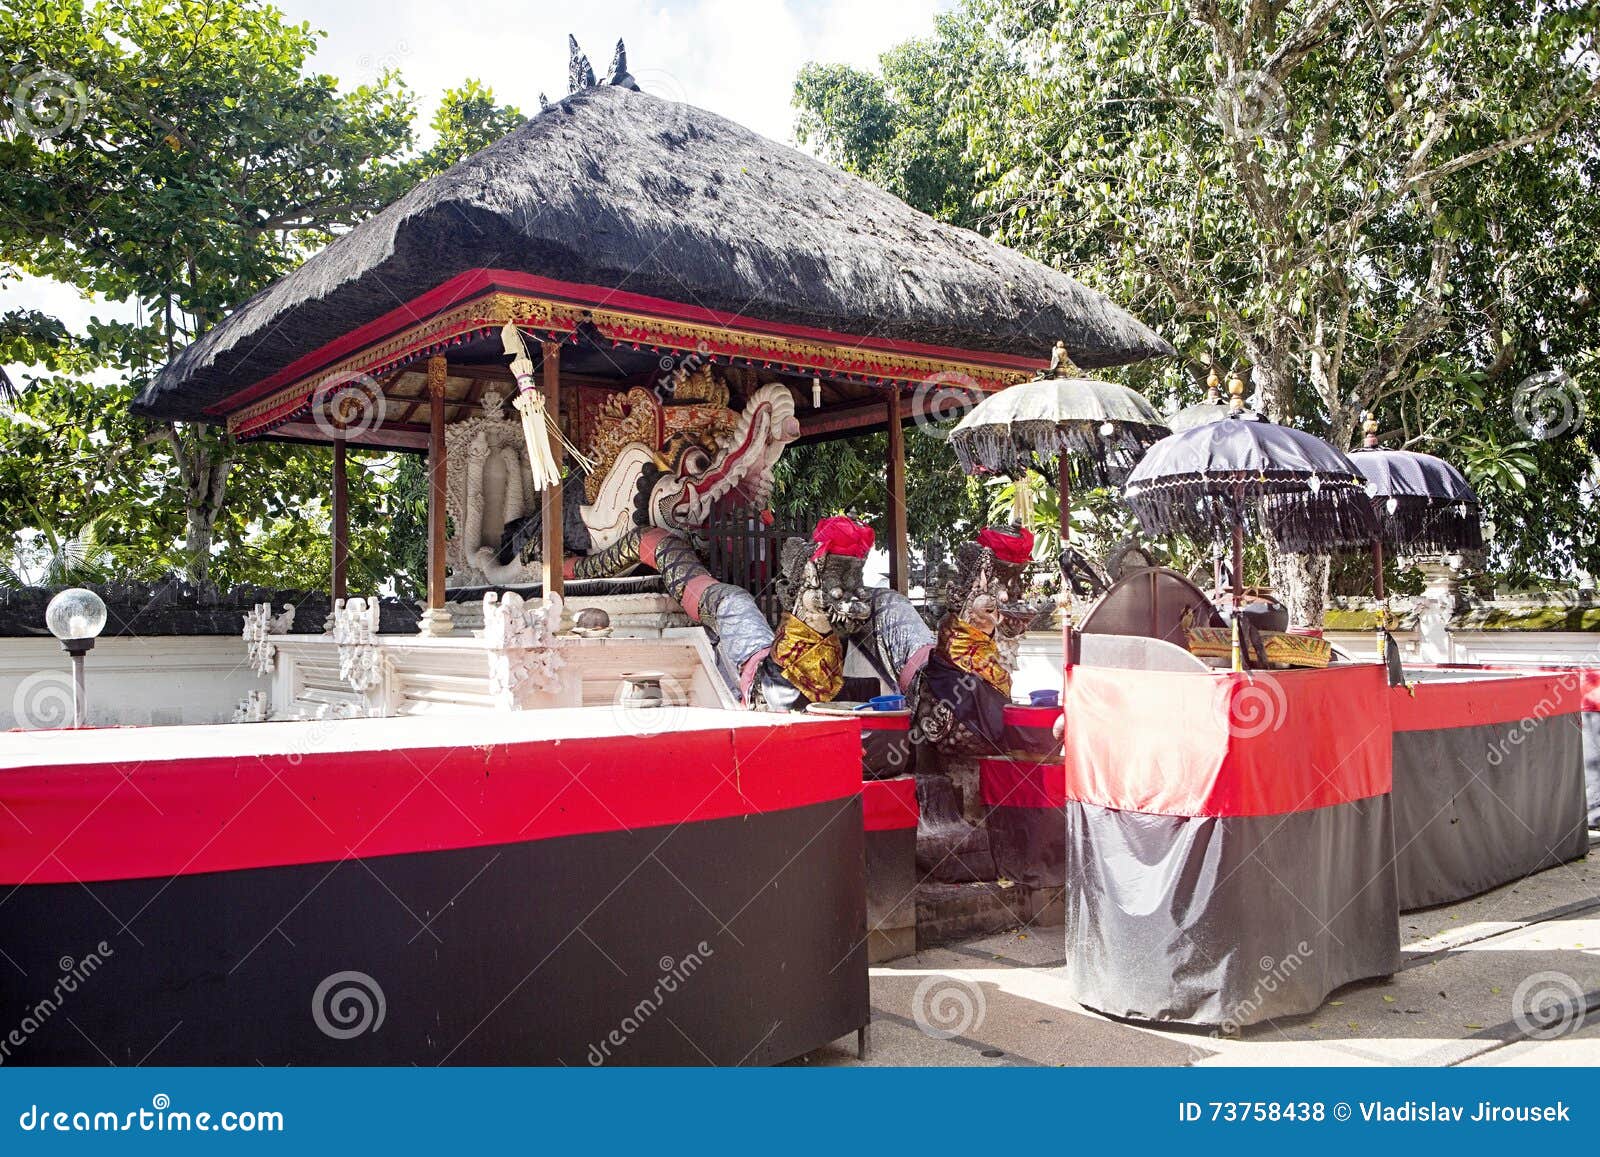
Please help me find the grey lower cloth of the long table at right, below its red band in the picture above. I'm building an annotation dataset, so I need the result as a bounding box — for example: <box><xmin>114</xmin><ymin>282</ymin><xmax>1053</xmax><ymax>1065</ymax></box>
<box><xmin>1394</xmin><ymin>714</ymin><xmax>1592</xmax><ymax>911</ymax></box>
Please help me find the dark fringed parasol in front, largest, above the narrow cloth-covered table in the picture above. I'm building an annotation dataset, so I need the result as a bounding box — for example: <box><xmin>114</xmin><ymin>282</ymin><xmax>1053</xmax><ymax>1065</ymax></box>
<box><xmin>1123</xmin><ymin>379</ymin><xmax>1378</xmax><ymax>671</ymax></box>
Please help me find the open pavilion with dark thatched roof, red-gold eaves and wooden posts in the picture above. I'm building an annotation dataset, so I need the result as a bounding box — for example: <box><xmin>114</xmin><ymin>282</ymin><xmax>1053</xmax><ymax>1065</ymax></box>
<box><xmin>134</xmin><ymin>74</ymin><xmax>1171</xmax><ymax>633</ymax></box>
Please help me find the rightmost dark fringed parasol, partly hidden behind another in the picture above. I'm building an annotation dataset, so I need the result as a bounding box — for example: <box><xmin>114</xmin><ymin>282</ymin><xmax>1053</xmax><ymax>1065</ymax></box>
<box><xmin>1350</xmin><ymin>413</ymin><xmax>1483</xmax><ymax>665</ymax></box>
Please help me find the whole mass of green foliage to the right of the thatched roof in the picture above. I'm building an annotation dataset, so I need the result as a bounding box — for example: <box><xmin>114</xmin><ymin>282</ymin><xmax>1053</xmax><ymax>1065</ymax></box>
<box><xmin>797</xmin><ymin>0</ymin><xmax>1600</xmax><ymax>604</ymax></box>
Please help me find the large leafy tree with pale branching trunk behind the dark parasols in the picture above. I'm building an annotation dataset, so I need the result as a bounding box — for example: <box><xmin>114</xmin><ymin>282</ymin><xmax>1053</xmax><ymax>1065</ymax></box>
<box><xmin>955</xmin><ymin>0</ymin><xmax>1600</xmax><ymax>621</ymax></box>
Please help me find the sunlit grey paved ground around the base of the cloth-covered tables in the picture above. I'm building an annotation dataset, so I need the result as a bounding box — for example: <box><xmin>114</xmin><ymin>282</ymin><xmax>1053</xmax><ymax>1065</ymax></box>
<box><xmin>797</xmin><ymin>845</ymin><xmax>1600</xmax><ymax>1066</ymax></box>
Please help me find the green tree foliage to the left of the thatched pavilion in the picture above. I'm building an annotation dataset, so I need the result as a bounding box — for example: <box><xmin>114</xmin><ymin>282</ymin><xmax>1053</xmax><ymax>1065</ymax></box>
<box><xmin>0</xmin><ymin>0</ymin><xmax>522</xmax><ymax>591</ymax></box>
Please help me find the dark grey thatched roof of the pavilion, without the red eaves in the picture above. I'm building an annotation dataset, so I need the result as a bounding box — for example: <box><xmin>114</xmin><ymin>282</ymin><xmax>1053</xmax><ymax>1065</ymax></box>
<box><xmin>134</xmin><ymin>86</ymin><xmax>1171</xmax><ymax>418</ymax></box>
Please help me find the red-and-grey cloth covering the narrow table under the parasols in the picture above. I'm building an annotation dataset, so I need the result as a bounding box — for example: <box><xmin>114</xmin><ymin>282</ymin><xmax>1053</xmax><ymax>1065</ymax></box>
<box><xmin>1062</xmin><ymin>666</ymin><xmax>1400</xmax><ymax>1026</ymax></box>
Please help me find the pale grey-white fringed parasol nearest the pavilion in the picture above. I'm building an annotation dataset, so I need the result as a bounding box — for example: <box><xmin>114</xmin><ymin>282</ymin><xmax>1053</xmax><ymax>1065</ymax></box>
<box><xmin>950</xmin><ymin>341</ymin><xmax>1166</xmax><ymax>553</ymax></box>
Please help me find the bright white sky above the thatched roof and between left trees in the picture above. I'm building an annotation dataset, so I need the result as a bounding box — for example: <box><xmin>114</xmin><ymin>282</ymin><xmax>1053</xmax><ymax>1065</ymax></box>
<box><xmin>0</xmin><ymin>0</ymin><xmax>954</xmax><ymax>378</ymax></box>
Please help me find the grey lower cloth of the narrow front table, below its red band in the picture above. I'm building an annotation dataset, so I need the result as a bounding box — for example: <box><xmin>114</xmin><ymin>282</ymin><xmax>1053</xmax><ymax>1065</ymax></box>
<box><xmin>1066</xmin><ymin>795</ymin><xmax>1400</xmax><ymax>1026</ymax></box>
